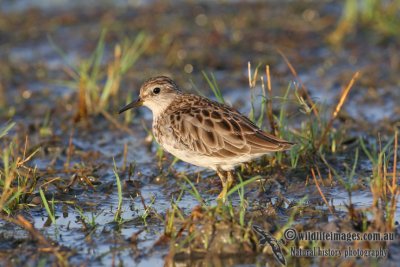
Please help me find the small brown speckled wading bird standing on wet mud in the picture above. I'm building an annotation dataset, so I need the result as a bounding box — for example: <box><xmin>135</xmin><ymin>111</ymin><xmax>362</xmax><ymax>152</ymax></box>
<box><xmin>119</xmin><ymin>76</ymin><xmax>293</xmax><ymax>199</ymax></box>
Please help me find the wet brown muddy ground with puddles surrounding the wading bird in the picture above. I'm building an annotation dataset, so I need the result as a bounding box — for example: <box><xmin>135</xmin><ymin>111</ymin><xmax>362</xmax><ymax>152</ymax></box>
<box><xmin>0</xmin><ymin>0</ymin><xmax>400</xmax><ymax>266</ymax></box>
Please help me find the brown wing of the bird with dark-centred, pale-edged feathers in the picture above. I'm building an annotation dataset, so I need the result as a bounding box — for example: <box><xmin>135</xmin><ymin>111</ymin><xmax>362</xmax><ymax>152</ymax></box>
<box><xmin>165</xmin><ymin>95</ymin><xmax>292</xmax><ymax>158</ymax></box>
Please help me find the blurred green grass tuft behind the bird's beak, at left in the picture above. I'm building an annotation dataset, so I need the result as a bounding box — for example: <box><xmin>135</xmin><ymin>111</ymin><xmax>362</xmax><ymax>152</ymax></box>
<box><xmin>49</xmin><ymin>30</ymin><xmax>150</xmax><ymax>121</ymax></box>
